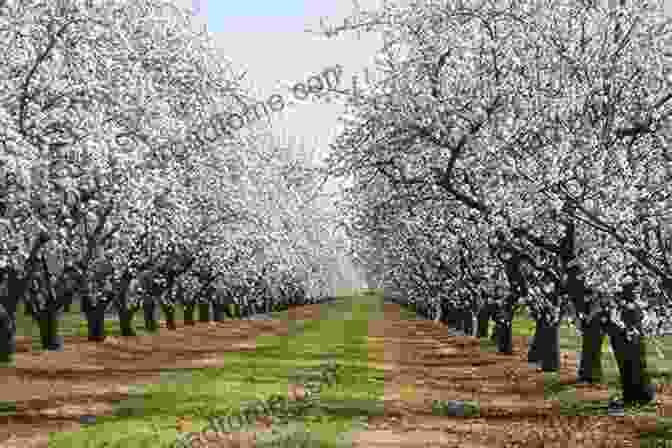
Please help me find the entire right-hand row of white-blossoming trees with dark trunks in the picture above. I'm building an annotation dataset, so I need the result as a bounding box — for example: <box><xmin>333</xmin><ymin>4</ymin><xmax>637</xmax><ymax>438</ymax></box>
<box><xmin>325</xmin><ymin>0</ymin><xmax>672</xmax><ymax>402</ymax></box>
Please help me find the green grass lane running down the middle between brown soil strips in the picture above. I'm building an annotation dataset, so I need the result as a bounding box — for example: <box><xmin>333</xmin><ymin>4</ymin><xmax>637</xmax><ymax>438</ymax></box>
<box><xmin>43</xmin><ymin>296</ymin><xmax>383</xmax><ymax>448</ymax></box>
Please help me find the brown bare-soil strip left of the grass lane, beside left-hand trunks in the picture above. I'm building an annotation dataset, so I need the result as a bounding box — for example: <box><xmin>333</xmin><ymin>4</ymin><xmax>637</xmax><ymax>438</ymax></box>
<box><xmin>0</xmin><ymin>305</ymin><xmax>320</xmax><ymax>448</ymax></box>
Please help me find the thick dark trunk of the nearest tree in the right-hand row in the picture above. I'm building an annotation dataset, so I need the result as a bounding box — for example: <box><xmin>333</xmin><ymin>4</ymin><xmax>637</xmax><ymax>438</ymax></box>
<box><xmin>608</xmin><ymin>324</ymin><xmax>656</xmax><ymax>404</ymax></box>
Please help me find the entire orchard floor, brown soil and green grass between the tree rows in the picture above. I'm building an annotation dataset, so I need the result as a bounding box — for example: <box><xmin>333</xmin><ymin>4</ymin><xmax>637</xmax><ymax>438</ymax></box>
<box><xmin>0</xmin><ymin>295</ymin><xmax>672</xmax><ymax>448</ymax></box>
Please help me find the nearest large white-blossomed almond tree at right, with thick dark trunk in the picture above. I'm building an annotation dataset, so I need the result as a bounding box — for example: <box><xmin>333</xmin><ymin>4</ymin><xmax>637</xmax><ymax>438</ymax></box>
<box><xmin>318</xmin><ymin>0</ymin><xmax>670</xmax><ymax>401</ymax></box>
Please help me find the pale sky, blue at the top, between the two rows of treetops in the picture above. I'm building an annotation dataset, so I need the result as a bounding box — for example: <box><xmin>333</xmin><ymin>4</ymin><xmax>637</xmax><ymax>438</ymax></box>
<box><xmin>173</xmin><ymin>0</ymin><xmax>382</xmax><ymax>163</ymax></box>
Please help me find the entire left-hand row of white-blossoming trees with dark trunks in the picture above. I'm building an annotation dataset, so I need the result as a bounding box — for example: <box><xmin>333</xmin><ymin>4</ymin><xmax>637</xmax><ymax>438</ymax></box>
<box><xmin>0</xmin><ymin>0</ymin><xmax>350</xmax><ymax>361</ymax></box>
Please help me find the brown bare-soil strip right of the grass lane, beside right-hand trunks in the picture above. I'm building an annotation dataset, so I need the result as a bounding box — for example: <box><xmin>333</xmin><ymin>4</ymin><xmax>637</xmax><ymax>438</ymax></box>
<box><xmin>346</xmin><ymin>303</ymin><xmax>672</xmax><ymax>448</ymax></box>
